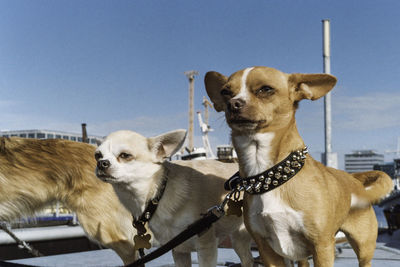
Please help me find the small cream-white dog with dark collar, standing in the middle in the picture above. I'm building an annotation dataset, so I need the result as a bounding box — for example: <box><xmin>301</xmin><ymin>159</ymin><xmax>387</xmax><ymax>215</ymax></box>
<box><xmin>96</xmin><ymin>130</ymin><xmax>252</xmax><ymax>267</ymax></box>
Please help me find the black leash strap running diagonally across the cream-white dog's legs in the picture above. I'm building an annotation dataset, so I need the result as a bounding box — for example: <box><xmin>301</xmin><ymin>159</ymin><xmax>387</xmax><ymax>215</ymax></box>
<box><xmin>128</xmin><ymin>206</ymin><xmax>224</xmax><ymax>267</ymax></box>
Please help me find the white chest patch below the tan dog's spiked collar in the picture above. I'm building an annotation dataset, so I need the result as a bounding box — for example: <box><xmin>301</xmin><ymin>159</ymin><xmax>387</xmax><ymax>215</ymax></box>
<box><xmin>247</xmin><ymin>191</ymin><xmax>310</xmax><ymax>260</ymax></box>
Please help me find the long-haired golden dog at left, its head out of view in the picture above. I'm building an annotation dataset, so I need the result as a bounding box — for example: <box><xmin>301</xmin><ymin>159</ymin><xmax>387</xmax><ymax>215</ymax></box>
<box><xmin>0</xmin><ymin>138</ymin><xmax>136</xmax><ymax>264</ymax></box>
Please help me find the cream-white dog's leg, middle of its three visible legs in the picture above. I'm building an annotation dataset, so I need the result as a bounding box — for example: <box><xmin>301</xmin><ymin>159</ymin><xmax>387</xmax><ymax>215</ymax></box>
<box><xmin>197</xmin><ymin>228</ymin><xmax>218</xmax><ymax>267</ymax></box>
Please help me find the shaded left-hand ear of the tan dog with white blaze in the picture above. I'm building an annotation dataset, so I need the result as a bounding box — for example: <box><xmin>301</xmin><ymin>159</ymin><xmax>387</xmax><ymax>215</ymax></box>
<box><xmin>204</xmin><ymin>71</ymin><xmax>228</xmax><ymax>112</ymax></box>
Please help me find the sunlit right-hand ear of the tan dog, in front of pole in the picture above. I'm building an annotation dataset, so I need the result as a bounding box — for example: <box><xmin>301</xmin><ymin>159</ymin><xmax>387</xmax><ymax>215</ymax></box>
<box><xmin>289</xmin><ymin>73</ymin><xmax>337</xmax><ymax>101</ymax></box>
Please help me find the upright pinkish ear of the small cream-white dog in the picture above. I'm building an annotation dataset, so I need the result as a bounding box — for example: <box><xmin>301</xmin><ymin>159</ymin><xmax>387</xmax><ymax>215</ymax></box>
<box><xmin>148</xmin><ymin>129</ymin><xmax>186</xmax><ymax>160</ymax></box>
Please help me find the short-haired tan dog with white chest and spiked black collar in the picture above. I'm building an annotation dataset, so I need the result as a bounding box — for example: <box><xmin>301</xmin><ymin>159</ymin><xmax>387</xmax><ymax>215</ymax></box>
<box><xmin>205</xmin><ymin>67</ymin><xmax>392</xmax><ymax>266</ymax></box>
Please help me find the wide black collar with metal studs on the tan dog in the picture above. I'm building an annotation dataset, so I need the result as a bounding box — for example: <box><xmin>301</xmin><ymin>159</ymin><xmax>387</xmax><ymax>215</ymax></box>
<box><xmin>225</xmin><ymin>147</ymin><xmax>308</xmax><ymax>195</ymax></box>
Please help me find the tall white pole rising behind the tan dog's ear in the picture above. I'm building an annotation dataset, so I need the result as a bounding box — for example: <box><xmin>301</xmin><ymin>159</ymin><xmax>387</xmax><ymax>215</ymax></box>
<box><xmin>322</xmin><ymin>19</ymin><xmax>335</xmax><ymax>167</ymax></box>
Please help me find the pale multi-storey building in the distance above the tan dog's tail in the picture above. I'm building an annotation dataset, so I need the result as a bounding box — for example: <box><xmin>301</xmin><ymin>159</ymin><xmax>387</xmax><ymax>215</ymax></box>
<box><xmin>344</xmin><ymin>150</ymin><xmax>384</xmax><ymax>173</ymax></box>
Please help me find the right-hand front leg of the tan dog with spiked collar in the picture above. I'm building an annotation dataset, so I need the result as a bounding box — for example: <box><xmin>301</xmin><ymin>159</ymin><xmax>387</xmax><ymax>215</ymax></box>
<box><xmin>313</xmin><ymin>240</ymin><xmax>335</xmax><ymax>267</ymax></box>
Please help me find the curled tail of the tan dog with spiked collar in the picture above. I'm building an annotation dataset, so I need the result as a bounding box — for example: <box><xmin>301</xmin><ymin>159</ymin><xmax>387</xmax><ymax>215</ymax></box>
<box><xmin>351</xmin><ymin>171</ymin><xmax>393</xmax><ymax>204</ymax></box>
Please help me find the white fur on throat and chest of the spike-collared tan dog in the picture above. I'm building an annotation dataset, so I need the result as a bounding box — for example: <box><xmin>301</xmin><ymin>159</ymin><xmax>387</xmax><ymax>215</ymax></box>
<box><xmin>232</xmin><ymin>133</ymin><xmax>310</xmax><ymax>260</ymax></box>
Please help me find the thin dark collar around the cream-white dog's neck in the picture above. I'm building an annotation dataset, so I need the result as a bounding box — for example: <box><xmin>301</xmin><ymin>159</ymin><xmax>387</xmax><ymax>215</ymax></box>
<box><xmin>132</xmin><ymin>171</ymin><xmax>168</xmax><ymax>234</ymax></box>
